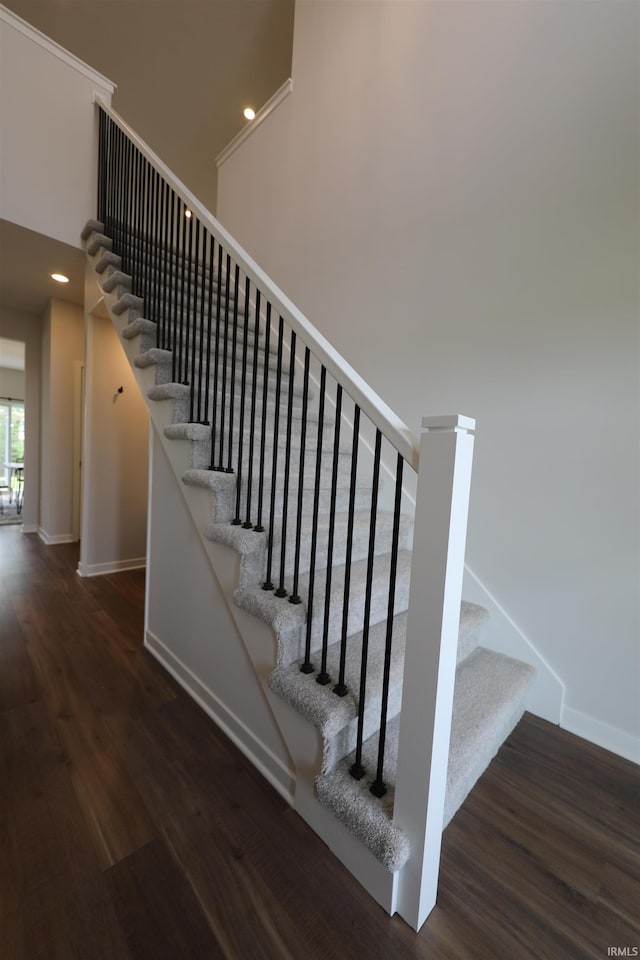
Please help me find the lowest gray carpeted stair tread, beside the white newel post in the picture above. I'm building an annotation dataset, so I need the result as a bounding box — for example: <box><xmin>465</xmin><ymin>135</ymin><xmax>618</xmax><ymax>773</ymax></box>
<box><xmin>316</xmin><ymin>647</ymin><xmax>535</xmax><ymax>870</ymax></box>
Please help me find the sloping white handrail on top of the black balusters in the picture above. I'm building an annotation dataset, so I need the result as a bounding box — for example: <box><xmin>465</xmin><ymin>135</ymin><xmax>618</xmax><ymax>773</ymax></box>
<box><xmin>94</xmin><ymin>94</ymin><xmax>420</xmax><ymax>472</ymax></box>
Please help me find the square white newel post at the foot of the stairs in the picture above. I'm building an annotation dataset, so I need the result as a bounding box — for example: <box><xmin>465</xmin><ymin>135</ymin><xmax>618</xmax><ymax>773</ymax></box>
<box><xmin>394</xmin><ymin>415</ymin><xmax>475</xmax><ymax>930</ymax></box>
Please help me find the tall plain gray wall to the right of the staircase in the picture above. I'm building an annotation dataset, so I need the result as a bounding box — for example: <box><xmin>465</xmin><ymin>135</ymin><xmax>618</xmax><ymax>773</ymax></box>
<box><xmin>218</xmin><ymin>0</ymin><xmax>640</xmax><ymax>753</ymax></box>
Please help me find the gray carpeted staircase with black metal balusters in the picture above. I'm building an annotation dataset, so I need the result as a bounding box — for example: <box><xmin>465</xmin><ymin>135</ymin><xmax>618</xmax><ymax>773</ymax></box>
<box><xmin>83</xmin><ymin>103</ymin><xmax>535</xmax><ymax>925</ymax></box>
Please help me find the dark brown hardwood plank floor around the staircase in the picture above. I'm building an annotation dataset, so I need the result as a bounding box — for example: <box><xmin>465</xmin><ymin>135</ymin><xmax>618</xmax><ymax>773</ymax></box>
<box><xmin>0</xmin><ymin>527</ymin><xmax>640</xmax><ymax>960</ymax></box>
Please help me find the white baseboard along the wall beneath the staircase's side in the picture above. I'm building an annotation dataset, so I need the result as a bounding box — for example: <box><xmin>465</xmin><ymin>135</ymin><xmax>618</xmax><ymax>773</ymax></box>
<box><xmin>144</xmin><ymin>630</ymin><xmax>295</xmax><ymax>806</ymax></box>
